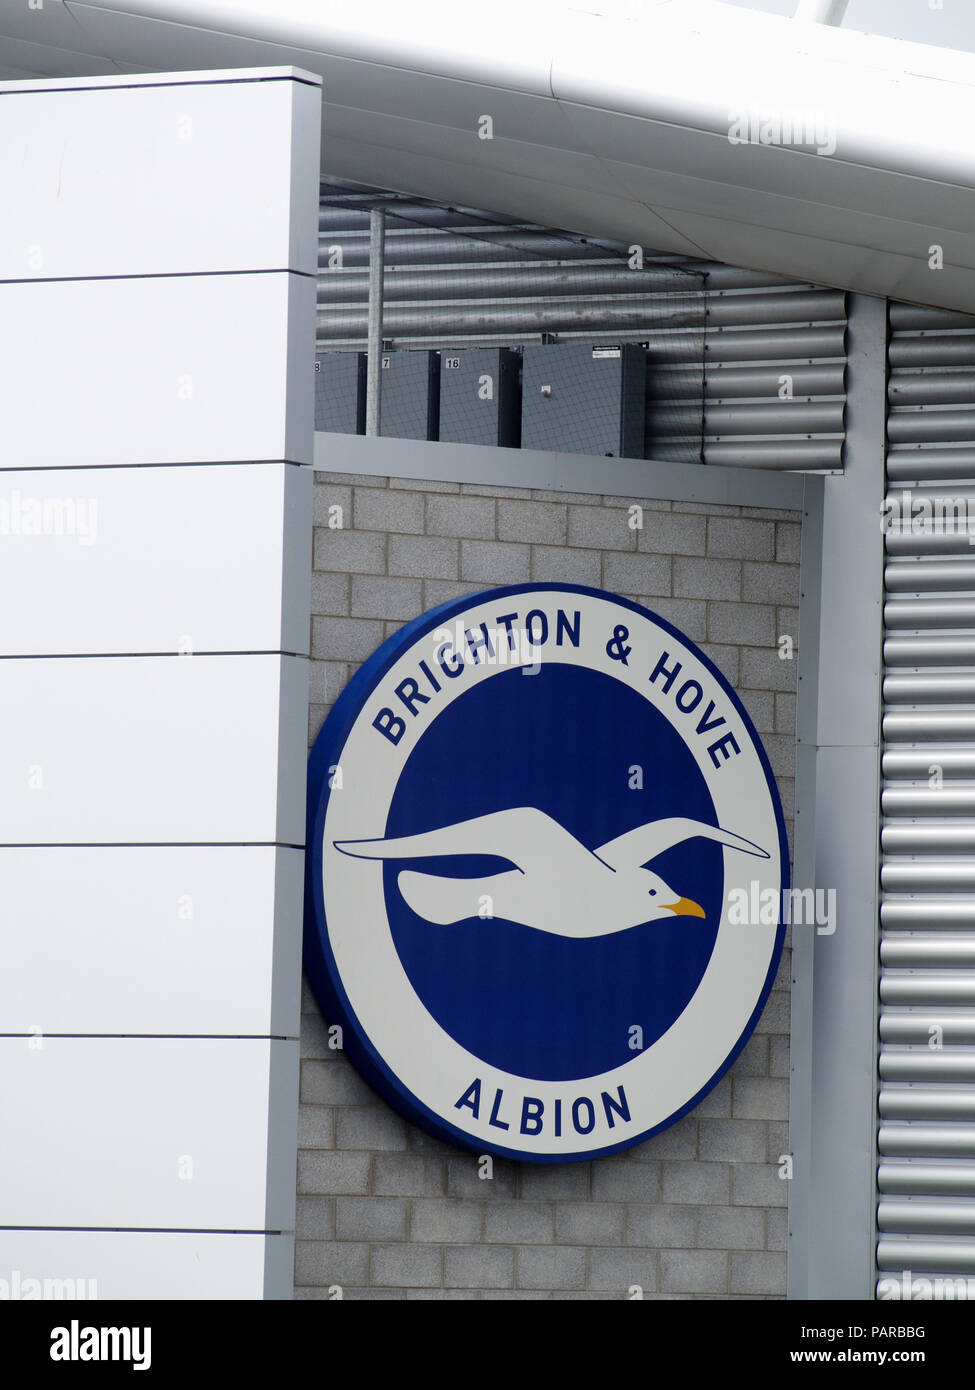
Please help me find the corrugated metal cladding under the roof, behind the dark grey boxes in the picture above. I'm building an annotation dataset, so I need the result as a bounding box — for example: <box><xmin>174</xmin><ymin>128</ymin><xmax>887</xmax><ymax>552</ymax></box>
<box><xmin>319</xmin><ymin>183</ymin><xmax>846</xmax><ymax>470</ymax></box>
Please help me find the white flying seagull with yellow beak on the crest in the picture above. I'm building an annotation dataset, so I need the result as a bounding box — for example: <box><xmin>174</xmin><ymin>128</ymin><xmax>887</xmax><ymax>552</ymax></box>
<box><xmin>334</xmin><ymin>806</ymin><xmax>769</xmax><ymax>937</ymax></box>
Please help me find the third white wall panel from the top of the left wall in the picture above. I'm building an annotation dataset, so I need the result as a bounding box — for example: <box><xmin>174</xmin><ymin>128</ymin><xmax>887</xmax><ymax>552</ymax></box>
<box><xmin>0</xmin><ymin>464</ymin><xmax>313</xmax><ymax>656</ymax></box>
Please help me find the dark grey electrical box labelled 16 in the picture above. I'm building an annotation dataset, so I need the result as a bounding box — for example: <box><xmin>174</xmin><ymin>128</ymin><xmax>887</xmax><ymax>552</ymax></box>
<box><xmin>440</xmin><ymin>348</ymin><xmax>522</xmax><ymax>449</ymax></box>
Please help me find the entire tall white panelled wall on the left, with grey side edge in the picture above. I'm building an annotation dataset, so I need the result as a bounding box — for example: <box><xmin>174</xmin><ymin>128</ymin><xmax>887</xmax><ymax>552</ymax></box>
<box><xmin>0</xmin><ymin>68</ymin><xmax>321</xmax><ymax>1298</ymax></box>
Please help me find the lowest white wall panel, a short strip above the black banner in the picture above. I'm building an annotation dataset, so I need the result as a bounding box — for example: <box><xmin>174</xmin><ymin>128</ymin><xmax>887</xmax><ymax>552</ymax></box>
<box><xmin>0</xmin><ymin>1230</ymin><xmax>295</xmax><ymax>1295</ymax></box>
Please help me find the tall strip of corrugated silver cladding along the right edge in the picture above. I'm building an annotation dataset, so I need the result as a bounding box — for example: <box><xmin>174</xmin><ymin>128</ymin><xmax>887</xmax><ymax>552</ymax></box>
<box><xmin>878</xmin><ymin>304</ymin><xmax>975</xmax><ymax>1297</ymax></box>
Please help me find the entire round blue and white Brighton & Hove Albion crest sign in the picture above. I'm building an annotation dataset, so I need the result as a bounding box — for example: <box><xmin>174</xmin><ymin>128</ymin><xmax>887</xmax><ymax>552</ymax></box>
<box><xmin>305</xmin><ymin>584</ymin><xmax>789</xmax><ymax>1163</ymax></box>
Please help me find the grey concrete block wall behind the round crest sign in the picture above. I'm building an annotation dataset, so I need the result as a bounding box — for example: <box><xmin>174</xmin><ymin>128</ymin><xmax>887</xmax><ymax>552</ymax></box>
<box><xmin>295</xmin><ymin>473</ymin><xmax>804</xmax><ymax>1300</ymax></box>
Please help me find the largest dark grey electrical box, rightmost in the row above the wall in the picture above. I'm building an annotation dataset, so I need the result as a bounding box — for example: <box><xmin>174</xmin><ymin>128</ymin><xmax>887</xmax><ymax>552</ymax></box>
<box><xmin>522</xmin><ymin>343</ymin><xmax>647</xmax><ymax>459</ymax></box>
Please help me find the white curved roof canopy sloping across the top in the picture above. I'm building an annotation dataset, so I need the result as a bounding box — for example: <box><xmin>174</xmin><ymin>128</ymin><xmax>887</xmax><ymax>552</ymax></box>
<box><xmin>0</xmin><ymin>0</ymin><xmax>975</xmax><ymax>313</ymax></box>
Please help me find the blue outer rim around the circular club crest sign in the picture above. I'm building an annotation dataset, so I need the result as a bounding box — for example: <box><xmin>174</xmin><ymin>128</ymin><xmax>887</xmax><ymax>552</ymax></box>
<box><xmin>303</xmin><ymin>582</ymin><xmax>791</xmax><ymax>1163</ymax></box>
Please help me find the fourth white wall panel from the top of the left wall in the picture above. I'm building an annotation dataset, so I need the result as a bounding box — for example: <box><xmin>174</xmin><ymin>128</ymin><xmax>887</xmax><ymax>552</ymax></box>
<box><xmin>0</xmin><ymin>656</ymin><xmax>307</xmax><ymax>845</ymax></box>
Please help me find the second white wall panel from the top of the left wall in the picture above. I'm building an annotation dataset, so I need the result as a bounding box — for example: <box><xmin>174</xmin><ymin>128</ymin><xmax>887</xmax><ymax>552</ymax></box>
<box><xmin>0</xmin><ymin>272</ymin><xmax>307</xmax><ymax>468</ymax></box>
